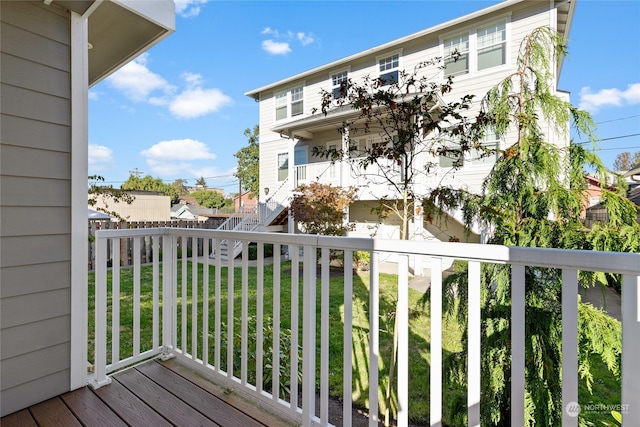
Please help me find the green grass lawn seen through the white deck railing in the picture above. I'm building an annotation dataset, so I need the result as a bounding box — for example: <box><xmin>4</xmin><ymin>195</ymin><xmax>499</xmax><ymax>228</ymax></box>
<box><xmin>89</xmin><ymin>262</ymin><xmax>620</xmax><ymax>424</ymax></box>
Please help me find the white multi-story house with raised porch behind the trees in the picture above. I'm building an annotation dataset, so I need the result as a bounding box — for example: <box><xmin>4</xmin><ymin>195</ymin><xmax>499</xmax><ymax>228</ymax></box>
<box><xmin>246</xmin><ymin>0</ymin><xmax>576</xmax><ymax>246</ymax></box>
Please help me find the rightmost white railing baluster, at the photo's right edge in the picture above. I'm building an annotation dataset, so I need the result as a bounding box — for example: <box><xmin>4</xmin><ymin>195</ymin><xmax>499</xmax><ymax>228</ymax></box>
<box><xmin>620</xmin><ymin>274</ymin><xmax>640</xmax><ymax>427</ymax></box>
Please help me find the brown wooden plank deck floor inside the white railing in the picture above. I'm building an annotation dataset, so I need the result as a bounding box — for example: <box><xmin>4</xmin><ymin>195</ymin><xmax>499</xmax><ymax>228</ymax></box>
<box><xmin>0</xmin><ymin>360</ymin><xmax>292</xmax><ymax>427</ymax></box>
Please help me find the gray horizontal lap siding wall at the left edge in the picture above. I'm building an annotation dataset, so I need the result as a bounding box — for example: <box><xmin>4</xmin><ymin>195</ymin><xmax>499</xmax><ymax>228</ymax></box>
<box><xmin>0</xmin><ymin>1</ymin><xmax>71</xmax><ymax>415</ymax></box>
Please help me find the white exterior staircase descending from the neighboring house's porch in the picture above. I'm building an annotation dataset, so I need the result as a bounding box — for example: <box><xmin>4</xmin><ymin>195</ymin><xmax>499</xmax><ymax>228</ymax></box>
<box><xmin>210</xmin><ymin>179</ymin><xmax>291</xmax><ymax>260</ymax></box>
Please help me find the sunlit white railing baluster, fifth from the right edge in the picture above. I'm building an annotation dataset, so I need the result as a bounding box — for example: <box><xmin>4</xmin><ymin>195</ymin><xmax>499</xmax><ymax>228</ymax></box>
<box><xmin>432</xmin><ymin>257</ymin><xmax>442</xmax><ymax>427</ymax></box>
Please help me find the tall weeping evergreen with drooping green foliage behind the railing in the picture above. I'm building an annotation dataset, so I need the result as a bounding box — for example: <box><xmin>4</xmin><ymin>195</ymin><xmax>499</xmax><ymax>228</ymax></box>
<box><xmin>425</xmin><ymin>28</ymin><xmax>640</xmax><ymax>426</ymax></box>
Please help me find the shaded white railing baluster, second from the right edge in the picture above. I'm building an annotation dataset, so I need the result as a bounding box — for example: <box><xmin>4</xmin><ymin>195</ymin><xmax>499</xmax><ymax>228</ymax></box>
<box><xmin>562</xmin><ymin>269</ymin><xmax>578</xmax><ymax>427</ymax></box>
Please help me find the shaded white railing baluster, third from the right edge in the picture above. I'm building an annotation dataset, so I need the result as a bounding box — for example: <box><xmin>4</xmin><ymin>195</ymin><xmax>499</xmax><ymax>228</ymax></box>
<box><xmin>511</xmin><ymin>264</ymin><xmax>525</xmax><ymax>426</ymax></box>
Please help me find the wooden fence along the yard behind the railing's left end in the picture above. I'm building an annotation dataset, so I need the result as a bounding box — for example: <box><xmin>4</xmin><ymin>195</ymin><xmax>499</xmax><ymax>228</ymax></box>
<box><xmin>88</xmin><ymin>218</ymin><xmax>226</xmax><ymax>271</ymax></box>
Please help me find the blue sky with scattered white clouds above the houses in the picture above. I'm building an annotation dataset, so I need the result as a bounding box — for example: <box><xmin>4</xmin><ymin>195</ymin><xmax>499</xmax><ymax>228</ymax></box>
<box><xmin>89</xmin><ymin>0</ymin><xmax>640</xmax><ymax>193</ymax></box>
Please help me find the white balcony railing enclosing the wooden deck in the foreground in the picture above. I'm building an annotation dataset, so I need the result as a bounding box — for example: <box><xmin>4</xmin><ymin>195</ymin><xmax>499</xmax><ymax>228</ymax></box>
<box><xmin>92</xmin><ymin>228</ymin><xmax>640</xmax><ymax>426</ymax></box>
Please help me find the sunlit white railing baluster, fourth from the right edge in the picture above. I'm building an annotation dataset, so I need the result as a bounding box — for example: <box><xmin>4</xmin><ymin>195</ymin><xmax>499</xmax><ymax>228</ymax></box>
<box><xmin>467</xmin><ymin>261</ymin><xmax>481</xmax><ymax>427</ymax></box>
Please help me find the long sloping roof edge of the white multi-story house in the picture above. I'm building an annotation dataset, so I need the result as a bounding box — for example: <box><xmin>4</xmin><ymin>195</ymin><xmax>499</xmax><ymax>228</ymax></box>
<box><xmin>245</xmin><ymin>0</ymin><xmax>576</xmax><ymax>100</ymax></box>
